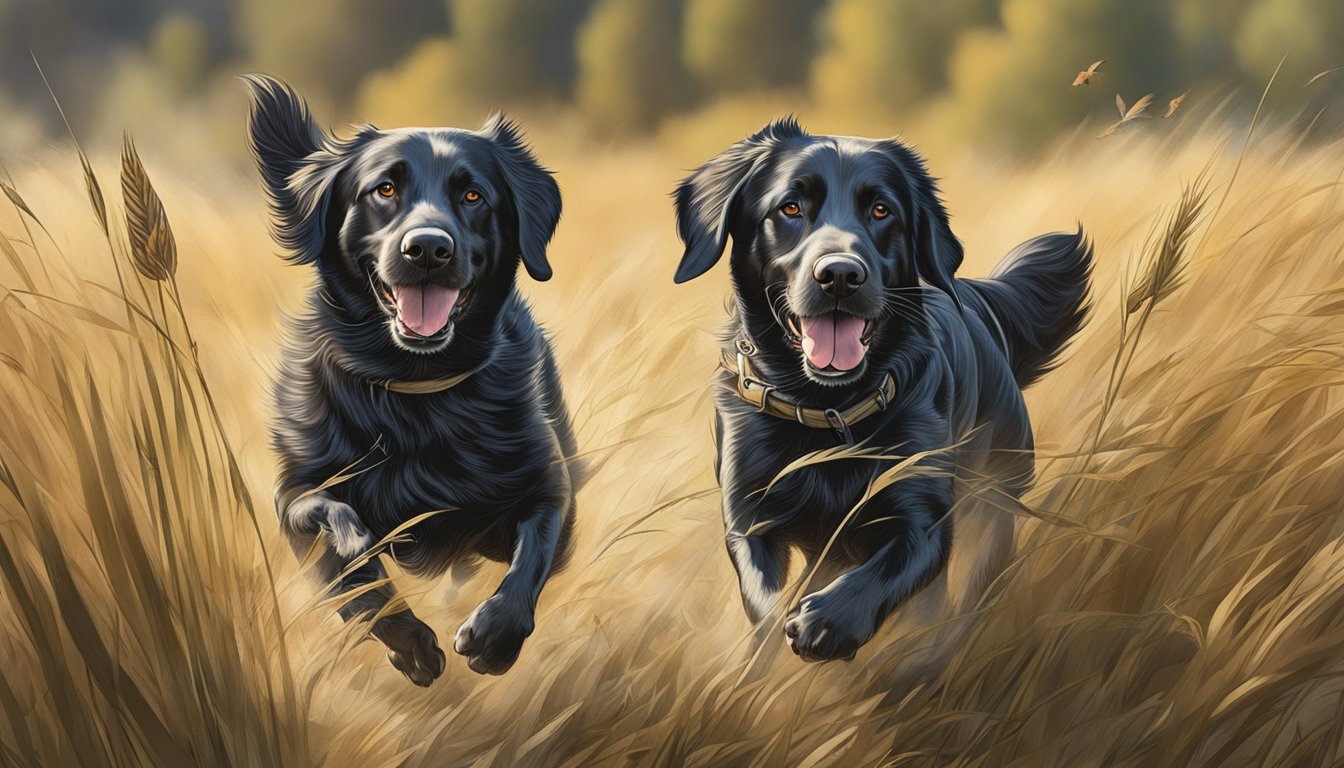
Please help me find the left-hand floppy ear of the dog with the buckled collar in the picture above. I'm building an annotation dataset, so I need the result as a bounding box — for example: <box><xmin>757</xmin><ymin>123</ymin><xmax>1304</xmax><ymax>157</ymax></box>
<box><xmin>672</xmin><ymin>117</ymin><xmax>806</xmax><ymax>282</ymax></box>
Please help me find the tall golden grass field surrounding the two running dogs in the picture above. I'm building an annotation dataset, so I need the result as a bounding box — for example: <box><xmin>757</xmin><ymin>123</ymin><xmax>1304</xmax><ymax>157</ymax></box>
<box><xmin>0</xmin><ymin>104</ymin><xmax>1344</xmax><ymax>768</ymax></box>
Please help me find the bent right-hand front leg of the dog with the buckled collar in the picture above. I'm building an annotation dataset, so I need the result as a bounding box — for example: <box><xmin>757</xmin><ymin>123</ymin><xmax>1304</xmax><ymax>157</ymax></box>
<box><xmin>784</xmin><ymin>516</ymin><xmax>952</xmax><ymax>662</ymax></box>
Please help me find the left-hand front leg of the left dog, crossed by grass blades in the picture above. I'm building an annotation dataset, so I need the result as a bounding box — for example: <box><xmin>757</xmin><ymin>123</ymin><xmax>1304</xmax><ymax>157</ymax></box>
<box><xmin>277</xmin><ymin>490</ymin><xmax>446</xmax><ymax>686</ymax></box>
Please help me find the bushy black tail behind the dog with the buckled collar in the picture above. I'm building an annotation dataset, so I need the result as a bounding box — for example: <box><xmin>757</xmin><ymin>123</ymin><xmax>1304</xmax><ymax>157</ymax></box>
<box><xmin>957</xmin><ymin>226</ymin><xmax>1093</xmax><ymax>387</ymax></box>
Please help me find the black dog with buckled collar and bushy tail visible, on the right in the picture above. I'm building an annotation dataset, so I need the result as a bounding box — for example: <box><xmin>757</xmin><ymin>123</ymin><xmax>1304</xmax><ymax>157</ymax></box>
<box><xmin>676</xmin><ymin>120</ymin><xmax>1091</xmax><ymax>660</ymax></box>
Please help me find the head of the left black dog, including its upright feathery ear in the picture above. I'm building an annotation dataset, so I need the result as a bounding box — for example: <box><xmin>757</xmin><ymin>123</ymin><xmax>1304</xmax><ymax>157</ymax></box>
<box><xmin>245</xmin><ymin>75</ymin><xmax>560</xmax><ymax>354</ymax></box>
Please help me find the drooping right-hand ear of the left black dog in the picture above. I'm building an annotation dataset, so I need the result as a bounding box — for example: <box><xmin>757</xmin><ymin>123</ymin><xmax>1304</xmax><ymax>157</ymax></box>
<box><xmin>480</xmin><ymin>114</ymin><xmax>560</xmax><ymax>281</ymax></box>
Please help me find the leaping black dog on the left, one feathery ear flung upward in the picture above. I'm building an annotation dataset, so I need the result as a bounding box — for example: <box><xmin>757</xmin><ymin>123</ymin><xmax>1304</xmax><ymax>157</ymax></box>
<box><xmin>246</xmin><ymin>77</ymin><xmax>577</xmax><ymax>686</ymax></box>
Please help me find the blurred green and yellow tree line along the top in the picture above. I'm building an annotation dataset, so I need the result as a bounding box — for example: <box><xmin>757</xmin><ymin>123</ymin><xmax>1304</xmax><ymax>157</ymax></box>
<box><xmin>0</xmin><ymin>0</ymin><xmax>1344</xmax><ymax>147</ymax></box>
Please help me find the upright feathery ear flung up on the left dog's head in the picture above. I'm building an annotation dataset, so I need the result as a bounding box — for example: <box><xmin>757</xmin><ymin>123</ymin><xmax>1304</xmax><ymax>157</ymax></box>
<box><xmin>242</xmin><ymin>74</ymin><xmax>343</xmax><ymax>264</ymax></box>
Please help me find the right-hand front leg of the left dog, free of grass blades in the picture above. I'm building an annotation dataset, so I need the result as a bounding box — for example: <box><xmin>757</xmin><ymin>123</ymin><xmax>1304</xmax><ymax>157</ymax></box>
<box><xmin>453</xmin><ymin>498</ymin><xmax>570</xmax><ymax>675</ymax></box>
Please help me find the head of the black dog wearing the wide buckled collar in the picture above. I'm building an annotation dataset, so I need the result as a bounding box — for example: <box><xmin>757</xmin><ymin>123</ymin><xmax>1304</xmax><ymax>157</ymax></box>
<box><xmin>675</xmin><ymin>118</ymin><xmax>962</xmax><ymax>385</ymax></box>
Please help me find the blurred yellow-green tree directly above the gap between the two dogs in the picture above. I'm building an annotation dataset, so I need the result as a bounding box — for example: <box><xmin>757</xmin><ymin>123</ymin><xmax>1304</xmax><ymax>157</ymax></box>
<box><xmin>577</xmin><ymin>0</ymin><xmax>685</xmax><ymax>133</ymax></box>
